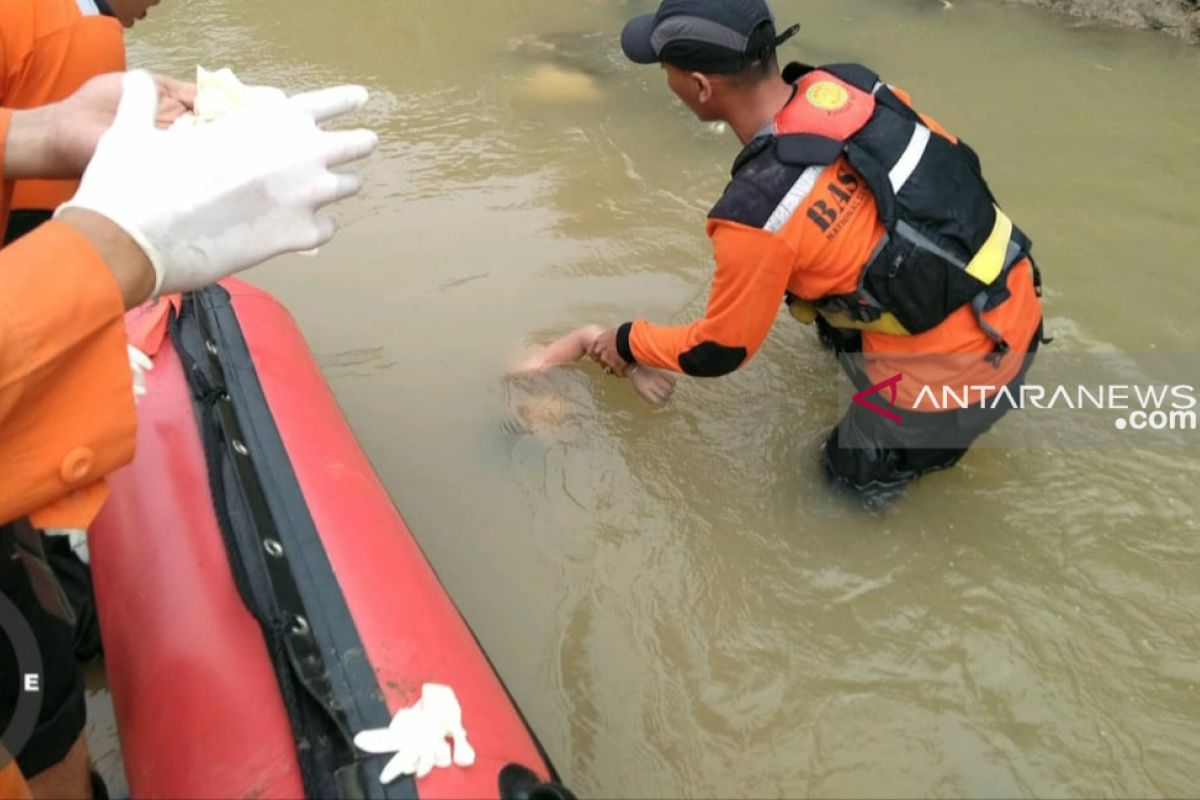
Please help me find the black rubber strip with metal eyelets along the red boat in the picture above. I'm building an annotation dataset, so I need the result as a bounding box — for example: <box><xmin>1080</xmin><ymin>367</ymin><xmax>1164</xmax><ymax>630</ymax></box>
<box><xmin>170</xmin><ymin>287</ymin><xmax>416</xmax><ymax>800</ymax></box>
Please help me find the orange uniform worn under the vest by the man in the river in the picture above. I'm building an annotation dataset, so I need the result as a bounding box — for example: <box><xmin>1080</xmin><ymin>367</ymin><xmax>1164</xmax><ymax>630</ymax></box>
<box><xmin>617</xmin><ymin>90</ymin><xmax>1042</xmax><ymax>402</ymax></box>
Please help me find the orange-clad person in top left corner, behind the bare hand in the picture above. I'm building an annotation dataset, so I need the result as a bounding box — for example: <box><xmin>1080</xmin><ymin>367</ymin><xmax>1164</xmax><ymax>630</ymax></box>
<box><xmin>0</xmin><ymin>0</ymin><xmax>158</xmax><ymax>242</ymax></box>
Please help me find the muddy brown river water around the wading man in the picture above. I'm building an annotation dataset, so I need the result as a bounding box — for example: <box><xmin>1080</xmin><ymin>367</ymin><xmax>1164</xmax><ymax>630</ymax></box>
<box><xmin>84</xmin><ymin>0</ymin><xmax>1200</xmax><ymax>798</ymax></box>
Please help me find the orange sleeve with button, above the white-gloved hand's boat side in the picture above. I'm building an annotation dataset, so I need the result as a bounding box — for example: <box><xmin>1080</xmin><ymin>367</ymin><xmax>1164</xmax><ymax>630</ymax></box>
<box><xmin>0</xmin><ymin>222</ymin><xmax>137</xmax><ymax>528</ymax></box>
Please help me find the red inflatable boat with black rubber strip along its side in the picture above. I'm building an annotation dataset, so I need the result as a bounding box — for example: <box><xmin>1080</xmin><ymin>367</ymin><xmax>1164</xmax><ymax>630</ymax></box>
<box><xmin>89</xmin><ymin>281</ymin><xmax>570</xmax><ymax>799</ymax></box>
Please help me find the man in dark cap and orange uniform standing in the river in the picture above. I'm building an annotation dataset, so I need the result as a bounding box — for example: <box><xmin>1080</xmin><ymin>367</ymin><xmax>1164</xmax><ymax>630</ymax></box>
<box><xmin>592</xmin><ymin>0</ymin><xmax>1042</xmax><ymax>500</ymax></box>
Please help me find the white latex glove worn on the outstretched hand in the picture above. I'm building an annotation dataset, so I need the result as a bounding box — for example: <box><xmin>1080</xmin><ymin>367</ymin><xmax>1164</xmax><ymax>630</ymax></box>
<box><xmin>60</xmin><ymin>70</ymin><xmax>378</xmax><ymax>295</ymax></box>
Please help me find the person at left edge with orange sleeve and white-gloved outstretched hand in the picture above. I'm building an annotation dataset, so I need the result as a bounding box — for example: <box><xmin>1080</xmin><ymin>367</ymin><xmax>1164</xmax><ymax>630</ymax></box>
<box><xmin>0</xmin><ymin>73</ymin><xmax>377</xmax><ymax>798</ymax></box>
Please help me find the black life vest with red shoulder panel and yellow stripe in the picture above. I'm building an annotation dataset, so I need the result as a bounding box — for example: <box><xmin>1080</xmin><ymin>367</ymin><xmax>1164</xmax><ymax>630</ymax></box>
<box><xmin>714</xmin><ymin>64</ymin><xmax>1038</xmax><ymax>354</ymax></box>
